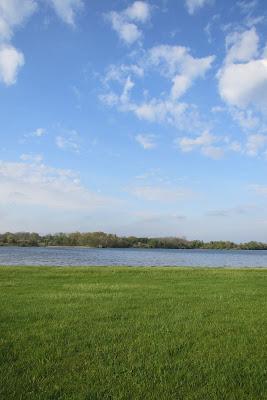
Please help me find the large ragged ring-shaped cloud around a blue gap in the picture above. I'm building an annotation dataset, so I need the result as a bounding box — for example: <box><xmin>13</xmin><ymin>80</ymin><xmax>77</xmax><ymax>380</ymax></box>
<box><xmin>99</xmin><ymin>45</ymin><xmax>214</xmax><ymax>131</ymax></box>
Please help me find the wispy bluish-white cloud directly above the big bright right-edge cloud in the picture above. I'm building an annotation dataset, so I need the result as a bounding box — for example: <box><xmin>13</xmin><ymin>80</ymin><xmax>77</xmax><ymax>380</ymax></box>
<box><xmin>225</xmin><ymin>27</ymin><xmax>259</xmax><ymax>64</ymax></box>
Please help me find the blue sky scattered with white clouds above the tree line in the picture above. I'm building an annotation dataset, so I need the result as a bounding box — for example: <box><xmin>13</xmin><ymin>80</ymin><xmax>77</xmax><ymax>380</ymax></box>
<box><xmin>0</xmin><ymin>0</ymin><xmax>267</xmax><ymax>241</ymax></box>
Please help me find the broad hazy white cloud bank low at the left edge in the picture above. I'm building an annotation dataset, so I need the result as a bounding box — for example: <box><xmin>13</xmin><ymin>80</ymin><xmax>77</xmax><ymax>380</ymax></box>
<box><xmin>0</xmin><ymin>161</ymin><xmax>110</xmax><ymax>210</ymax></box>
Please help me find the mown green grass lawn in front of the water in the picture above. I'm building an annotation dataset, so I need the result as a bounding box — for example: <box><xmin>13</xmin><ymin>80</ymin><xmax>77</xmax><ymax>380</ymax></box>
<box><xmin>0</xmin><ymin>267</ymin><xmax>267</xmax><ymax>400</ymax></box>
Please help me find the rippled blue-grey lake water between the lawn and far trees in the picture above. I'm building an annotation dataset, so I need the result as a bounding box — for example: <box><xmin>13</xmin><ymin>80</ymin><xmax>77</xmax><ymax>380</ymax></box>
<box><xmin>0</xmin><ymin>247</ymin><xmax>267</xmax><ymax>267</ymax></box>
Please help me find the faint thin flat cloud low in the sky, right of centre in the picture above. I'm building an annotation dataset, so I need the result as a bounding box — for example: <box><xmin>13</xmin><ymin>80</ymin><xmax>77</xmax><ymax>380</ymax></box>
<box><xmin>130</xmin><ymin>185</ymin><xmax>192</xmax><ymax>203</ymax></box>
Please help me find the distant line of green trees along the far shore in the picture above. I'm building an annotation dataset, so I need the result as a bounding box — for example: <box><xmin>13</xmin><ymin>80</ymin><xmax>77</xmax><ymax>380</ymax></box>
<box><xmin>0</xmin><ymin>232</ymin><xmax>267</xmax><ymax>250</ymax></box>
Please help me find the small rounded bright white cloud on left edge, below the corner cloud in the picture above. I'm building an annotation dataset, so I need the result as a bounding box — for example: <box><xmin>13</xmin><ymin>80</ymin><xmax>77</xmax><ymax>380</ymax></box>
<box><xmin>0</xmin><ymin>44</ymin><xmax>25</xmax><ymax>86</ymax></box>
